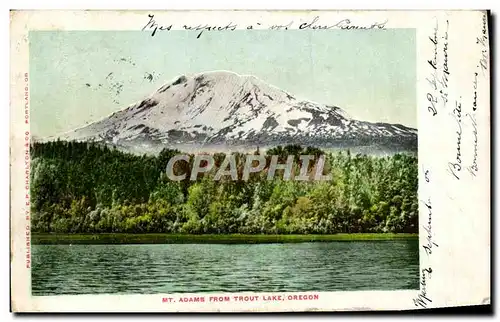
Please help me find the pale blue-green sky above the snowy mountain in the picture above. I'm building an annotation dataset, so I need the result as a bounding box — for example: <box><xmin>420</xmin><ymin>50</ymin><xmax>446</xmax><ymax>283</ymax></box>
<box><xmin>29</xmin><ymin>29</ymin><xmax>417</xmax><ymax>137</ymax></box>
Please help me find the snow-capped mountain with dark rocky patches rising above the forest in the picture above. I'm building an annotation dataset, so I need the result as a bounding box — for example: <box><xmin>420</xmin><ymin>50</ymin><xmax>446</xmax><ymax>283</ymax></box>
<box><xmin>60</xmin><ymin>71</ymin><xmax>417</xmax><ymax>151</ymax></box>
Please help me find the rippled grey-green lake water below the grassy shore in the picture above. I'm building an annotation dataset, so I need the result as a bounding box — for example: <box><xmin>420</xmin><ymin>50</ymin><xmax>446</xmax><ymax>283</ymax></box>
<box><xmin>32</xmin><ymin>239</ymin><xmax>419</xmax><ymax>295</ymax></box>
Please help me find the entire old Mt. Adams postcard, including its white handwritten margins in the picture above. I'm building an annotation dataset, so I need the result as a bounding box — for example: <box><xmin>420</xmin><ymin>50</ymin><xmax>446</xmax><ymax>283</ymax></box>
<box><xmin>10</xmin><ymin>10</ymin><xmax>491</xmax><ymax>312</ymax></box>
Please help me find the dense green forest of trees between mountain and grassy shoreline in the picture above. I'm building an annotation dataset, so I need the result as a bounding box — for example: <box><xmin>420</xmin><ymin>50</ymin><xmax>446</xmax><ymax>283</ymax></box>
<box><xmin>31</xmin><ymin>141</ymin><xmax>418</xmax><ymax>234</ymax></box>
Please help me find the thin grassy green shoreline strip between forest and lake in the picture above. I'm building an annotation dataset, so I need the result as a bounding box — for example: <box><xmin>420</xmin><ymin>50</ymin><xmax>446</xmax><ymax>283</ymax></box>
<box><xmin>31</xmin><ymin>233</ymin><xmax>418</xmax><ymax>245</ymax></box>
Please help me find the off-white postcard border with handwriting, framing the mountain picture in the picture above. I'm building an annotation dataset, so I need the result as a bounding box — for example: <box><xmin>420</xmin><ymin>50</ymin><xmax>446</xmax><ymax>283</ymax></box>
<box><xmin>10</xmin><ymin>11</ymin><xmax>491</xmax><ymax>312</ymax></box>
